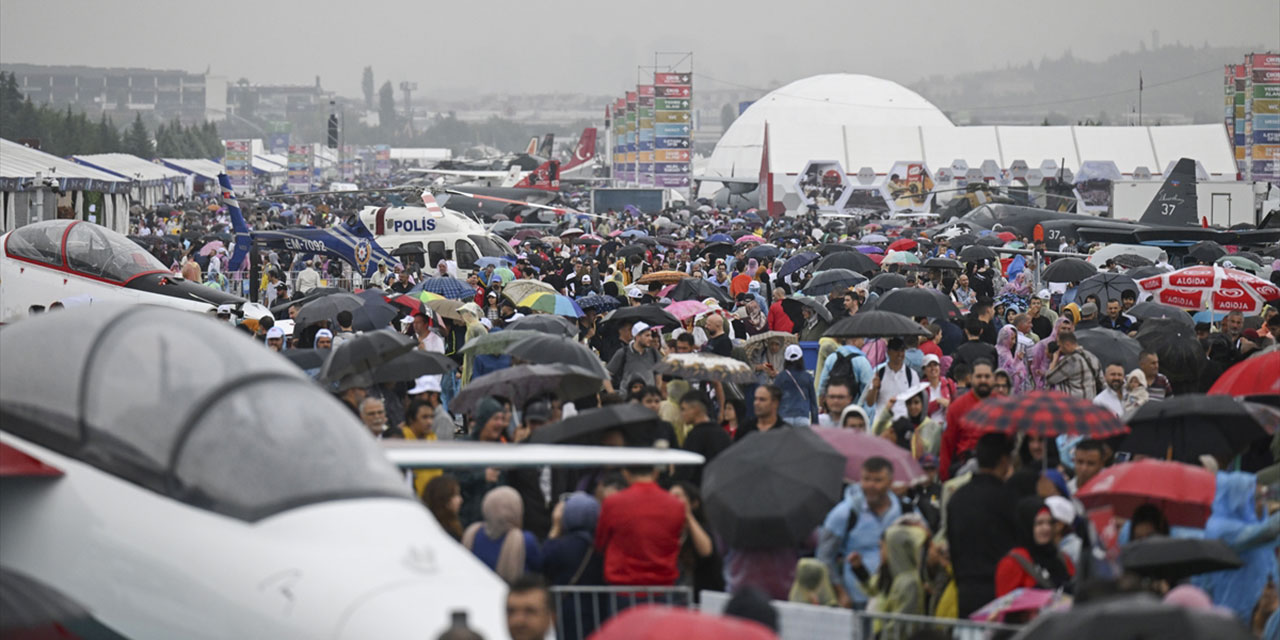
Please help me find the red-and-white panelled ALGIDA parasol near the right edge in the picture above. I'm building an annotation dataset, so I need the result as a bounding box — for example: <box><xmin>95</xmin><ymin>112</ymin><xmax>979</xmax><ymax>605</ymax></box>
<box><xmin>1138</xmin><ymin>265</ymin><xmax>1280</xmax><ymax>315</ymax></box>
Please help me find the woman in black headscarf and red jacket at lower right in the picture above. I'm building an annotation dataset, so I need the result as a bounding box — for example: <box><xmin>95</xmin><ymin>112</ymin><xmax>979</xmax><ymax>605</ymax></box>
<box><xmin>996</xmin><ymin>497</ymin><xmax>1075</xmax><ymax>598</ymax></box>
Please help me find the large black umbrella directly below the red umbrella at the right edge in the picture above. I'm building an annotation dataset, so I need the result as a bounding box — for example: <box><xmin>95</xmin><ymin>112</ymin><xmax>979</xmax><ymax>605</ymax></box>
<box><xmin>1120</xmin><ymin>393</ymin><xmax>1275</xmax><ymax>463</ymax></box>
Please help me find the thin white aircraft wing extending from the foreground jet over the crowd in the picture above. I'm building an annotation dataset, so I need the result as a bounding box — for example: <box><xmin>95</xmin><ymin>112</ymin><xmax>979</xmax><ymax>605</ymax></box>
<box><xmin>381</xmin><ymin>440</ymin><xmax>705</xmax><ymax>468</ymax></box>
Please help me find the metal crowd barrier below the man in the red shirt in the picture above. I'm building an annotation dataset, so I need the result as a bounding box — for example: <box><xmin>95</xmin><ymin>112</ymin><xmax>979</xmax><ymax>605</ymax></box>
<box><xmin>552</xmin><ymin>586</ymin><xmax>694</xmax><ymax>640</ymax></box>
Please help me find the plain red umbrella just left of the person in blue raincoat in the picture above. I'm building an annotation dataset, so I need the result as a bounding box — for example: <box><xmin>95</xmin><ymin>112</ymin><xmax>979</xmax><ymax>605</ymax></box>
<box><xmin>1075</xmin><ymin>460</ymin><xmax>1217</xmax><ymax>529</ymax></box>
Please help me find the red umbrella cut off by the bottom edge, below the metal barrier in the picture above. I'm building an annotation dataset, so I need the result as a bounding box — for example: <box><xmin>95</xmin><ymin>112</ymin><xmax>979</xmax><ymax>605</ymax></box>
<box><xmin>591</xmin><ymin>604</ymin><xmax>778</xmax><ymax>640</ymax></box>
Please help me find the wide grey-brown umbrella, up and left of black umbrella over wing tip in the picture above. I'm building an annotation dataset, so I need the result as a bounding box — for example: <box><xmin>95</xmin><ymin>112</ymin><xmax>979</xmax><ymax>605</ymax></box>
<box><xmin>449</xmin><ymin>364</ymin><xmax>603</xmax><ymax>413</ymax></box>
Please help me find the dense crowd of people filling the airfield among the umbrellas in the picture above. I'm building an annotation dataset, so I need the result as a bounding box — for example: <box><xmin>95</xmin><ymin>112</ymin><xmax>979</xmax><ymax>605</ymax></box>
<box><xmin>129</xmin><ymin>190</ymin><xmax>1280</xmax><ymax>639</ymax></box>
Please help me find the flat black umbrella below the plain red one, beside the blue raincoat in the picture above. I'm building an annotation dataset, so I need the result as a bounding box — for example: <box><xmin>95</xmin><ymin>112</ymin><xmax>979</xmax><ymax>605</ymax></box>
<box><xmin>1120</xmin><ymin>536</ymin><xmax>1244</xmax><ymax>584</ymax></box>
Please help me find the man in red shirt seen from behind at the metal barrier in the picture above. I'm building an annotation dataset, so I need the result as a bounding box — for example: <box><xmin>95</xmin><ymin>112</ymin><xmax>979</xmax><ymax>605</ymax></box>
<box><xmin>595</xmin><ymin>467</ymin><xmax>685</xmax><ymax>586</ymax></box>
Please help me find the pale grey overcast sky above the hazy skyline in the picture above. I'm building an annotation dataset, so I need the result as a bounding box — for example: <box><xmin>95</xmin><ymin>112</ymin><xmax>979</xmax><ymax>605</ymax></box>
<box><xmin>0</xmin><ymin>0</ymin><xmax>1280</xmax><ymax>96</ymax></box>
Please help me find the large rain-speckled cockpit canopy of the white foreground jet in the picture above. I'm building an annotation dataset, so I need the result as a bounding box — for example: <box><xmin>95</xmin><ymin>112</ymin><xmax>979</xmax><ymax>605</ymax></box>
<box><xmin>0</xmin><ymin>305</ymin><xmax>411</xmax><ymax>520</ymax></box>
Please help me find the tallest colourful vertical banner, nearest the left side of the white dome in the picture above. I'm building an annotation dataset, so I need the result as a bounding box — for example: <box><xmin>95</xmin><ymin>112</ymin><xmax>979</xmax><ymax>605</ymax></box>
<box><xmin>653</xmin><ymin>72</ymin><xmax>694</xmax><ymax>189</ymax></box>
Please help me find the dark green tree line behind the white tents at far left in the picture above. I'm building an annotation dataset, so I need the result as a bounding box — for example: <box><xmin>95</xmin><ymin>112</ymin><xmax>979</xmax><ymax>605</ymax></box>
<box><xmin>0</xmin><ymin>72</ymin><xmax>223</xmax><ymax>160</ymax></box>
